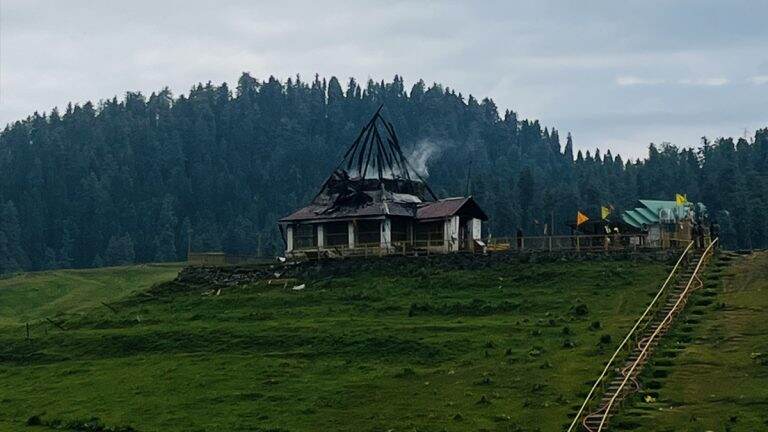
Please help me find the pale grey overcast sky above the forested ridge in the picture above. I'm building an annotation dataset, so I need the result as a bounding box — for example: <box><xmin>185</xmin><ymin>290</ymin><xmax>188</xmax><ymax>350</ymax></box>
<box><xmin>0</xmin><ymin>0</ymin><xmax>768</xmax><ymax>157</ymax></box>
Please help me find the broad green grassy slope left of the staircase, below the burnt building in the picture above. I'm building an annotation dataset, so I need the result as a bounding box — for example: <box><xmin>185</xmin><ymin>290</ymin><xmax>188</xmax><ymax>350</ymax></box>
<box><xmin>0</xmin><ymin>262</ymin><xmax>665</xmax><ymax>432</ymax></box>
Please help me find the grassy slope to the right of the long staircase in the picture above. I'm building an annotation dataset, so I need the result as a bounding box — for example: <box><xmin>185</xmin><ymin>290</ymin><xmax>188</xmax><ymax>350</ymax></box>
<box><xmin>618</xmin><ymin>252</ymin><xmax>768</xmax><ymax>432</ymax></box>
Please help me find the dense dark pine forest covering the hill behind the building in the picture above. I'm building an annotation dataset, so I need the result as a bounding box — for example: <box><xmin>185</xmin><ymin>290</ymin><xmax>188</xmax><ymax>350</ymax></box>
<box><xmin>0</xmin><ymin>74</ymin><xmax>768</xmax><ymax>273</ymax></box>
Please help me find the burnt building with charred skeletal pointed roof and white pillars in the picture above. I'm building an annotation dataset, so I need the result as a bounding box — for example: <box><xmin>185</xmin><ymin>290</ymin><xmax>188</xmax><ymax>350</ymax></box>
<box><xmin>279</xmin><ymin>107</ymin><xmax>488</xmax><ymax>257</ymax></box>
